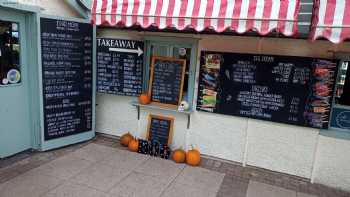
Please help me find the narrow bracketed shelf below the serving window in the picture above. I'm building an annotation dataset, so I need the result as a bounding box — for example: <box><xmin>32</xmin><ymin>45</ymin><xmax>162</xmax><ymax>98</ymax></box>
<box><xmin>130</xmin><ymin>101</ymin><xmax>193</xmax><ymax>129</ymax></box>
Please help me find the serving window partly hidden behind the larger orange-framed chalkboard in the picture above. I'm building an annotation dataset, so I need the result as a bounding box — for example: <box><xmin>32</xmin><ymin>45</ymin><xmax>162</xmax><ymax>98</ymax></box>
<box><xmin>145</xmin><ymin>38</ymin><xmax>197</xmax><ymax>109</ymax></box>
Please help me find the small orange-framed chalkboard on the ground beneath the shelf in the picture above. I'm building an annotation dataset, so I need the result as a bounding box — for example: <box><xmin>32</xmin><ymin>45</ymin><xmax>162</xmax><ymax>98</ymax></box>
<box><xmin>147</xmin><ymin>115</ymin><xmax>174</xmax><ymax>145</ymax></box>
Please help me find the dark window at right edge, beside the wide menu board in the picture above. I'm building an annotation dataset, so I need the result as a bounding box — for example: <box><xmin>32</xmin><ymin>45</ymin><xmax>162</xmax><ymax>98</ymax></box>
<box><xmin>335</xmin><ymin>61</ymin><xmax>350</xmax><ymax>106</ymax></box>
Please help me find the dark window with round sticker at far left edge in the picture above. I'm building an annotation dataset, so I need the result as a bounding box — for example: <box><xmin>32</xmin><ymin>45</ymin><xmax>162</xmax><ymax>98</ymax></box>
<box><xmin>0</xmin><ymin>20</ymin><xmax>21</xmax><ymax>86</ymax></box>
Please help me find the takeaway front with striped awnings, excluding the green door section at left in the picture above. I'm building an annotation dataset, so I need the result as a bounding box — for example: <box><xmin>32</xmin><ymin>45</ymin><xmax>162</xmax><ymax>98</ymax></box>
<box><xmin>92</xmin><ymin>0</ymin><xmax>350</xmax><ymax>190</ymax></box>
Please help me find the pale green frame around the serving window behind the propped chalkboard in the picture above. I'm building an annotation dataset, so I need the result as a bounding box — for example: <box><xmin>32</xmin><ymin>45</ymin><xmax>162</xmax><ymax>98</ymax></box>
<box><xmin>143</xmin><ymin>36</ymin><xmax>199</xmax><ymax>111</ymax></box>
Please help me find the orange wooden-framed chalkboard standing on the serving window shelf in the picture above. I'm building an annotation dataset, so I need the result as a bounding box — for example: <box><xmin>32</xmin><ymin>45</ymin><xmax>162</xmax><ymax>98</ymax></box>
<box><xmin>148</xmin><ymin>57</ymin><xmax>186</xmax><ymax>107</ymax></box>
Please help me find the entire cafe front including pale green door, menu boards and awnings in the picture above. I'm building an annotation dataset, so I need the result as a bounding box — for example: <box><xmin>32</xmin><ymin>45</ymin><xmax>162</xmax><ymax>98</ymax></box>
<box><xmin>0</xmin><ymin>0</ymin><xmax>350</xmax><ymax>190</ymax></box>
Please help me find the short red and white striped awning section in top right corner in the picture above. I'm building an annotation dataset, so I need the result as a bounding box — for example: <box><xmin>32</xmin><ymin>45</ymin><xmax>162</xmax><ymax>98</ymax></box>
<box><xmin>312</xmin><ymin>0</ymin><xmax>350</xmax><ymax>43</ymax></box>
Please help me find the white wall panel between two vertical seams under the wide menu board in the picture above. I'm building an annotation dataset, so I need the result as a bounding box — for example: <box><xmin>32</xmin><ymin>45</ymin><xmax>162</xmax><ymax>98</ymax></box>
<box><xmin>247</xmin><ymin>119</ymin><xmax>318</xmax><ymax>178</ymax></box>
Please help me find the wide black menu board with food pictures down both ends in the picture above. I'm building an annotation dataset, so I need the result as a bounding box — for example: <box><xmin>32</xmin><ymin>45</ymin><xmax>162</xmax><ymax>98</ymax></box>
<box><xmin>197</xmin><ymin>51</ymin><xmax>337</xmax><ymax>128</ymax></box>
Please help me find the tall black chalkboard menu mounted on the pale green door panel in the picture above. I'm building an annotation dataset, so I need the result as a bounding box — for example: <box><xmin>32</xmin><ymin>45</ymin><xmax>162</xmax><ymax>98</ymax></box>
<box><xmin>40</xmin><ymin>18</ymin><xmax>93</xmax><ymax>140</ymax></box>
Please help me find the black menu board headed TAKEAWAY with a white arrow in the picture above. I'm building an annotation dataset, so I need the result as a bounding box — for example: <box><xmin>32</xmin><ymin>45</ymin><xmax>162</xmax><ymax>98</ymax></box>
<box><xmin>97</xmin><ymin>38</ymin><xmax>143</xmax><ymax>96</ymax></box>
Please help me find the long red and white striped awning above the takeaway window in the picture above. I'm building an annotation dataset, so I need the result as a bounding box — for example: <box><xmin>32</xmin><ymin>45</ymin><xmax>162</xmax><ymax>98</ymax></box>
<box><xmin>92</xmin><ymin>0</ymin><xmax>299</xmax><ymax>36</ymax></box>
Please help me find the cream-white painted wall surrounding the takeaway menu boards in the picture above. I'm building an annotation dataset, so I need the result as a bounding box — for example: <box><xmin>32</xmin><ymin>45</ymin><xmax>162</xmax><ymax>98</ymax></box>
<box><xmin>96</xmin><ymin>29</ymin><xmax>350</xmax><ymax>190</ymax></box>
